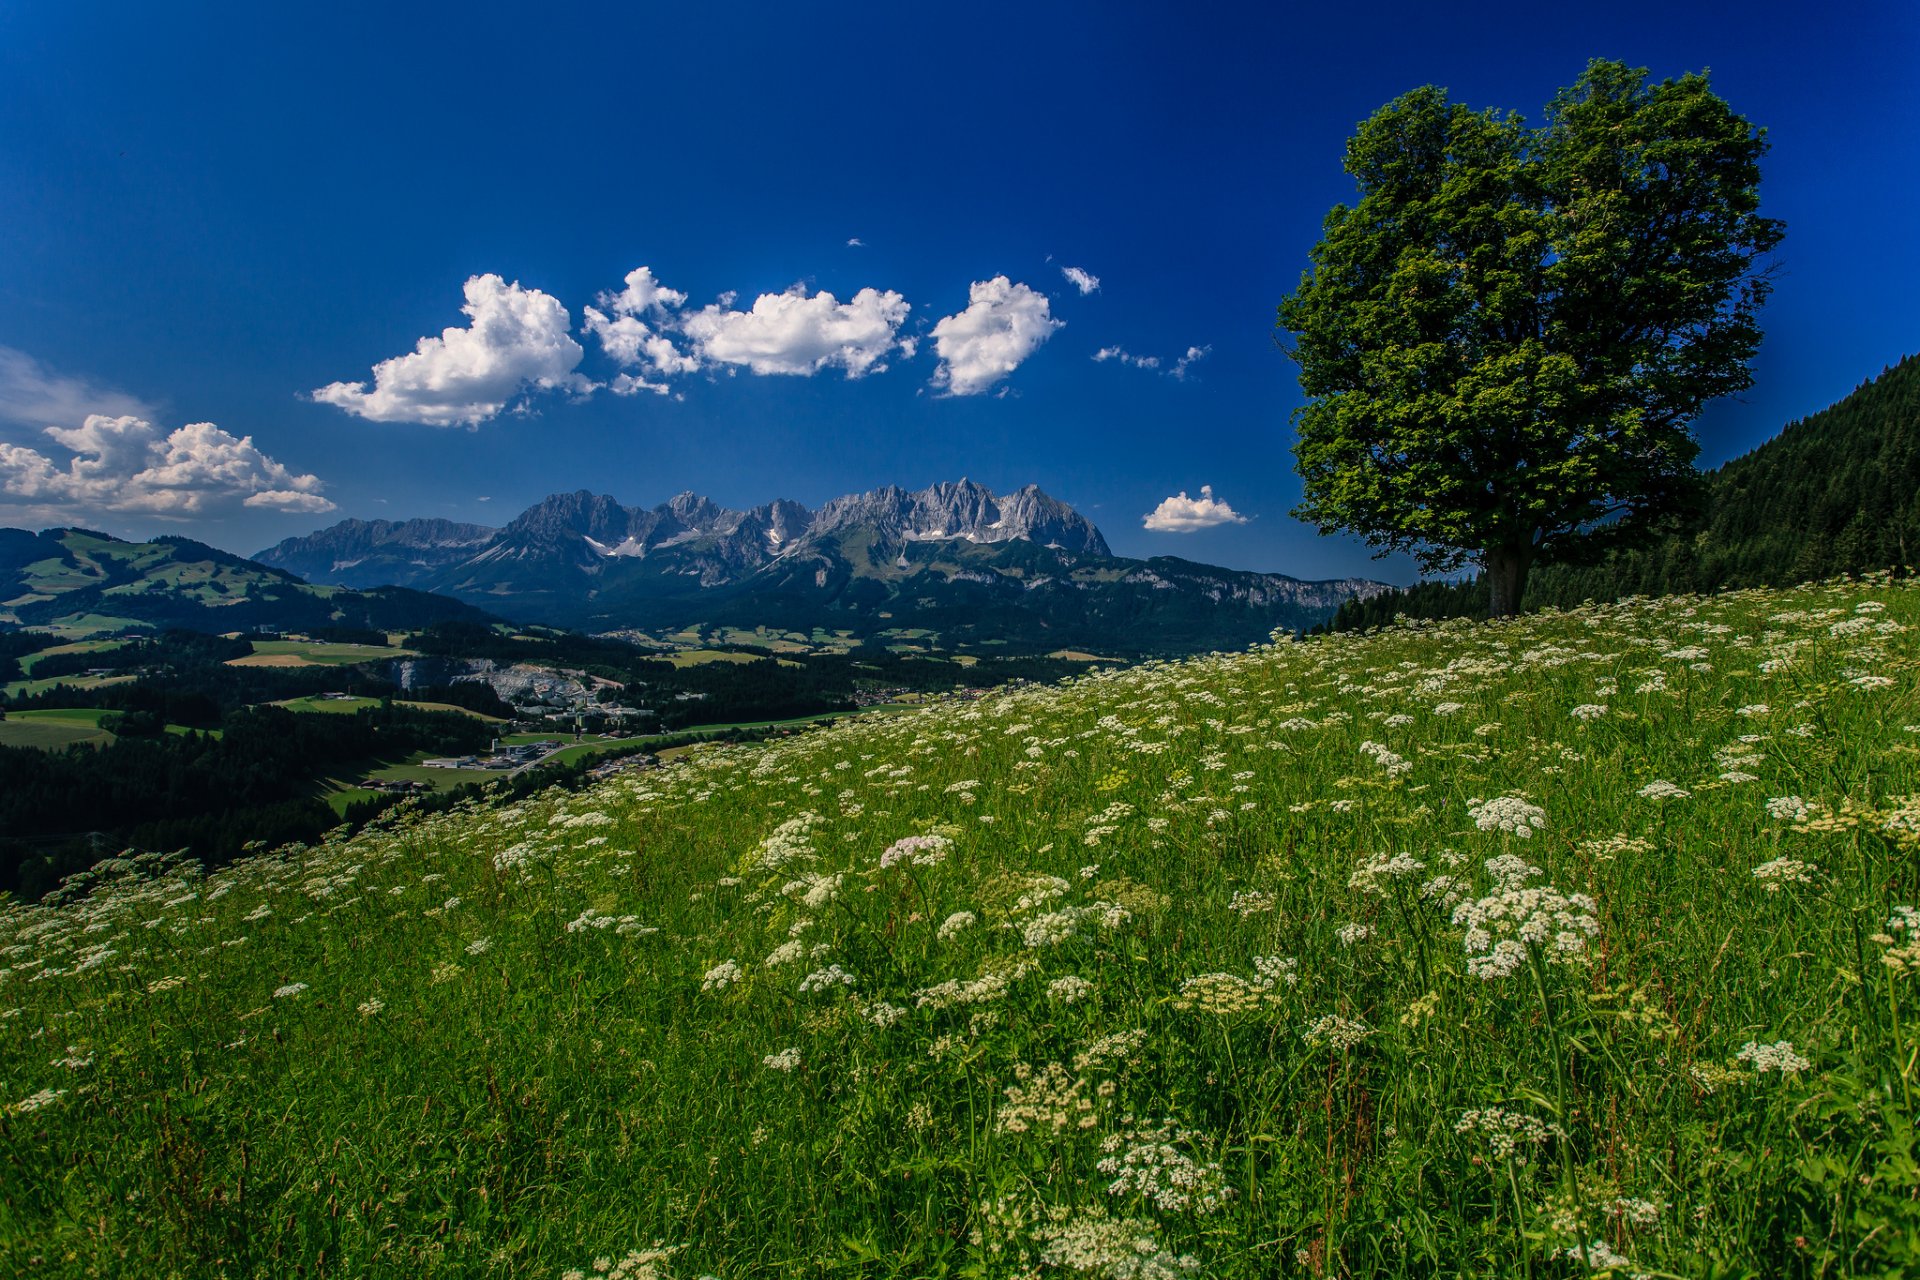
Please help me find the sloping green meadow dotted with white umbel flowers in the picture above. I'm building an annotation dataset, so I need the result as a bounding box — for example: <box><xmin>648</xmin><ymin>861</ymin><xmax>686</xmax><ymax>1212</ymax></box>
<box><xmin>0</xmin><ymin>580</ymin><xmax>1920</xmax><ymax>1280</ymax></box>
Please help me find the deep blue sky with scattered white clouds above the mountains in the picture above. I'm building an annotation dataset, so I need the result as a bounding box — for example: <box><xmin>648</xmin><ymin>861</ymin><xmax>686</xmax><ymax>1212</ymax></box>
<box><xmin>0</xmin><ymin>0</ymin><xmax>1920</xmax><ymax>581</ymax></box>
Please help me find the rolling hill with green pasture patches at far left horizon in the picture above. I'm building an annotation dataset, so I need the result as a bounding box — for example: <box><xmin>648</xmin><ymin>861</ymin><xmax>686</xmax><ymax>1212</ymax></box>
<box><xmin>0</xmin><ymin>530</ymin><xmax>488</xmax><ymax>631</ymax></box>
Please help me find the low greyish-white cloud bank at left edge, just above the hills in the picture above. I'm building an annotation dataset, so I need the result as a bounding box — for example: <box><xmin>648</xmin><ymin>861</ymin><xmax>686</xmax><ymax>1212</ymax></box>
<box><xmin>0</xmin><ymin>413</ymin><xmax>334</xmax><ymax>516</ymax></box>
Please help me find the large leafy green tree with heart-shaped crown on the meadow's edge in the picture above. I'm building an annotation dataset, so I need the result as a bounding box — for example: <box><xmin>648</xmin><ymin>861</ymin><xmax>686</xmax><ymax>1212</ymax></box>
<box><xmin>1279</xmin><ymin>61</ymin><xmax>1782</xmax><ymax>616</ymax></box>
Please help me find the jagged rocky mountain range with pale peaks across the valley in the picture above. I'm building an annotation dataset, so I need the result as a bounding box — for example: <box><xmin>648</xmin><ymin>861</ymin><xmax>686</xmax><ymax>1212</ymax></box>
<box><xmin>257</xmin><ymin>480</ymin><xmax>1382</xmax><ymax>652</ymax></box>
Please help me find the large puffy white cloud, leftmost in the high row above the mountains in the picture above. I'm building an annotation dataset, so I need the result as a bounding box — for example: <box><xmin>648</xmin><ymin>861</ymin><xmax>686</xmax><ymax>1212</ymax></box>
<box><xmin>313</xmin><ymin>269</ymin><xmax>583</xmax><ymax>426</ymax></box>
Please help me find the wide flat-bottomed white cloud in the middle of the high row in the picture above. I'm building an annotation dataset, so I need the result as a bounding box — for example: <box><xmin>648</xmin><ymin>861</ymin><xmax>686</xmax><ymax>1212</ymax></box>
<box><xmin>680</xmin><ymin>286</ymin><xmax>912</xmax><ymax>378</ymax></box>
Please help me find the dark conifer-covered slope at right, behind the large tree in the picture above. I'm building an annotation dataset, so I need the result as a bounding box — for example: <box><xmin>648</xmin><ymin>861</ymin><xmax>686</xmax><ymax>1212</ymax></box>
<box><xmin>1332</xmin><ymin>355</ymin><xmax>1920</xmax><ymax>629</ymax></box>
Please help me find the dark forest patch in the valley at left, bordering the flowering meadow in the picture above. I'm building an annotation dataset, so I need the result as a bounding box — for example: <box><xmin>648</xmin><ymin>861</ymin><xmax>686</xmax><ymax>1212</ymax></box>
<box><xmin>0</xmin><ymin>704</ymin><xmax>490</xmax><ymax>896</ymax></box>
